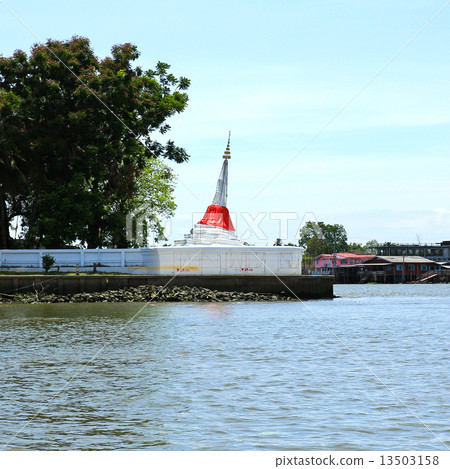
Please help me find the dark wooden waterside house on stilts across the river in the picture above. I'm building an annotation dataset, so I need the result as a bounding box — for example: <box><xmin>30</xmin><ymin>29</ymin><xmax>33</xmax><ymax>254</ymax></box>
<box><xmin>336</xmin><ymin>256</ymin><xmax>450</xmax><ymax>283</ymax></box>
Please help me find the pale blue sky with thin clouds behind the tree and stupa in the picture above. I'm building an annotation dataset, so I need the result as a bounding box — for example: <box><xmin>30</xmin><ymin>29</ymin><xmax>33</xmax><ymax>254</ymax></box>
<box><xmin>0</xmin><ymin>0</ymin><xmax>450</xmax><ymax>246</ymax></box>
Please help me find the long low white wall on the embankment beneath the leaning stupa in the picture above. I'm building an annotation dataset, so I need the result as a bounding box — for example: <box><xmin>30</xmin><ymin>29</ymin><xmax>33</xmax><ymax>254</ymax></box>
<box><xmin>0</xmin><ymin>246</ymin><xmax>303</xmax><ymax>275</ymax></box>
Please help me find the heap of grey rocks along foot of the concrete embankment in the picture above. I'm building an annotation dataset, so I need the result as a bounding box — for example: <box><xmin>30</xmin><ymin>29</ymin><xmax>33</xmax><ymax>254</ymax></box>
<box><xmin>0</xmin><ymin>285</ymin><xmax>295</xmax><ymax>304</ymax></box>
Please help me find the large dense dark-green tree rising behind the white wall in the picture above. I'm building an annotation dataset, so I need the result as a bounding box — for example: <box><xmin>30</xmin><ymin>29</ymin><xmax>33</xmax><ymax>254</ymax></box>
<box><xmin>0</xmin><ymin>37</ymin><xmax>189</xmax><ymax>248</ymax></box>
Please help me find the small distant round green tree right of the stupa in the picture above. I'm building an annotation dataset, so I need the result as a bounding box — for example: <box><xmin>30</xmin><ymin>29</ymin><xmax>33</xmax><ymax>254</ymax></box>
<box><xmin>298</xmin><ymin>221</ymin><xmax>348</xmax><ymax>257</ymax></box>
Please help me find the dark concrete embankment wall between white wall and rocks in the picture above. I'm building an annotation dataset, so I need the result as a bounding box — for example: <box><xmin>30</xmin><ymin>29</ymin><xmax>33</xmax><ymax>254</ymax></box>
<box><xmin>0</xmin><ymin>275</ymin><xmax>333</xmax><ymax>299</ymax></box>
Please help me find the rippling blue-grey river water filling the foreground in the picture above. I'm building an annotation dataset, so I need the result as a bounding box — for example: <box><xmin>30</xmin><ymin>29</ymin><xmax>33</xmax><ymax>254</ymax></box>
<box><xmin>0</xmin><ymin>285</ymin><xmax>450</xmax><ymax>451</ymax></box>
